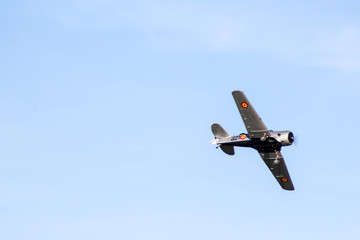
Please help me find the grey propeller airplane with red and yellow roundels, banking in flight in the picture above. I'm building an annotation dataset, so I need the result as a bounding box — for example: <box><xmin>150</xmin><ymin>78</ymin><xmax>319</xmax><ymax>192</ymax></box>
<box><xmin>211</xmin><ymin>90</ymin><xmax>295</xmax><ymax>190</ymax></box>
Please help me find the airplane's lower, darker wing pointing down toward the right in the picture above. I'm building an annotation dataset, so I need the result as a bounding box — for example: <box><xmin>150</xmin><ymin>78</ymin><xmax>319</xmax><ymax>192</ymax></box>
<box><xmin>259</xmin><ymin>151</ymin><xmax>295</xmax><ymax>190</ymax></box>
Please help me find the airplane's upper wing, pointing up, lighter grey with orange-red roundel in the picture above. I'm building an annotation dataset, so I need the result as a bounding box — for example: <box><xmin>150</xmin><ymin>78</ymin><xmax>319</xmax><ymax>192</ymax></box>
<box><xmin>232</xmin><ymin>90</ymin><xmax>268</xmax><ymax>138</ymax></box>
